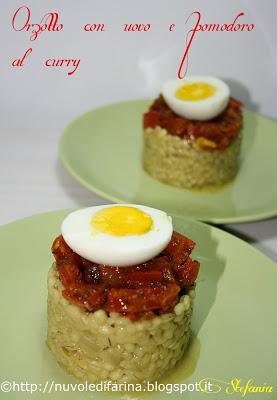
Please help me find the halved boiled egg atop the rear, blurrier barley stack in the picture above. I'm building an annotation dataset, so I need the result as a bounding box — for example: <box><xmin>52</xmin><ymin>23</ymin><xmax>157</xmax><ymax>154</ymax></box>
<box><xmin>162</xmin><ymin>75</ymin><xmax>230</xmax><ymax>121</ymax></box>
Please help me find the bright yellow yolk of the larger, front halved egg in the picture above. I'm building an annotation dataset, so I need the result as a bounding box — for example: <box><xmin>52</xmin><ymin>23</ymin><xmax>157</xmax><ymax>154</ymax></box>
<box><xmin>91</xmin><ymin>206</ymin><xmax>153</xmax><ymax>236</ymax></box>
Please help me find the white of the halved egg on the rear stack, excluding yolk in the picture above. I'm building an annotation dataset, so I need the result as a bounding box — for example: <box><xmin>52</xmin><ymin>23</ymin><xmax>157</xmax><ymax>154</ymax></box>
<box><xmin>162</xmin><ymin>75</ymin><xmax>230</xmax><ymax>121</ymax></box>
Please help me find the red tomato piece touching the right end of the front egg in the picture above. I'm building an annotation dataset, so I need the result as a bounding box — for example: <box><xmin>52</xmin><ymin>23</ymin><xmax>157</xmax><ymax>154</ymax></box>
<box><xmin>165</xmin><ymin>232</ymin><xmax>195</xmax><ymax>271</ymax></box>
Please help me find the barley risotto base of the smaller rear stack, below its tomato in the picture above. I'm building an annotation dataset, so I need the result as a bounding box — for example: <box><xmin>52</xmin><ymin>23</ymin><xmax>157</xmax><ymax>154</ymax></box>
<box><xmin>143</xmin><ymin>126</ymin><xmax>241</xmax><ymax>188</ymax></box>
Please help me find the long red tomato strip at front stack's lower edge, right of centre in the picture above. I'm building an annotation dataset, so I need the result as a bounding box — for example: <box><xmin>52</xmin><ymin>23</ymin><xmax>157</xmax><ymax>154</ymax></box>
<box><xmin>107</xmin><ymin>283</ymin><xmax>180</xmax><ymax>312</ymax></box>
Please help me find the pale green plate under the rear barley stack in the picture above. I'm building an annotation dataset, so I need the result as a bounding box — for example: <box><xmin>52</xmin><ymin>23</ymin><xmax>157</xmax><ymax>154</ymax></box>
<box><xmin>60</xmin><ymin>100</ymin><xmax>277</xmax><ymax>223</ymax></box>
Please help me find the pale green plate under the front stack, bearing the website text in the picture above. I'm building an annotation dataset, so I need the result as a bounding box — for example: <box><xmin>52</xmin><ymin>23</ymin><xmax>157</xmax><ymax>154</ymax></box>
<box><xmin>0</xmin><ymin>210</ymin><xmax>277</xmax><ymax>400</ymax></box>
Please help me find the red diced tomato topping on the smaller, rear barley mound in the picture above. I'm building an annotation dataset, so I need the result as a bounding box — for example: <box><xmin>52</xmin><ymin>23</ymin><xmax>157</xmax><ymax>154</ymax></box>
<box><xmin>144</xmin><ymin>95</ymin><xmax>243</xmax><ymax>150</ymax></box>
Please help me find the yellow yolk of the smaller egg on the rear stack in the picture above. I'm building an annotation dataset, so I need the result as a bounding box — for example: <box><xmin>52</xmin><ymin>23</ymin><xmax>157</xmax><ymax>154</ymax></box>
<box><xmin>175</xmin><ymin>82</ymin><xmax>215</xmax><ymax>101</ymax></box>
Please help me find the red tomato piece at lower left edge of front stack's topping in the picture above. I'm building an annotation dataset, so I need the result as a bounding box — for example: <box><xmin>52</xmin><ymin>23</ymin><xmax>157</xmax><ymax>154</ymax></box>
<box><xmin>62</xmin><ymin>284</ymin><xmax>106</xmax><ymax>311</ymax></box>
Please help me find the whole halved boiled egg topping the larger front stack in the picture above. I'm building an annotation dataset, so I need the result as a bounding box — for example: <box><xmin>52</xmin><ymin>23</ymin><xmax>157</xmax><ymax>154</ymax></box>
<box><xmin>61</xmin><ymin>204</ymin><xmax>173</xmax><ymax>267</ymax></box>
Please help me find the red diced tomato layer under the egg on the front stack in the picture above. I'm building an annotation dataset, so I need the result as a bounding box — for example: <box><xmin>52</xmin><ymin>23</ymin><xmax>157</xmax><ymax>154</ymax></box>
<box><xmin>52</xmin><ymin>232</ymin><xmax>199</xmax><ymax>321</ymax></box>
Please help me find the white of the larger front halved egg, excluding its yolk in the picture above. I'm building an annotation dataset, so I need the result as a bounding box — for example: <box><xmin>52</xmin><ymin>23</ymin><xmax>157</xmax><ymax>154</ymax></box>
<box><xmin>61</xmin><ymin>204</ymin><xmax>173</xmax><ymax>267</ymax></box>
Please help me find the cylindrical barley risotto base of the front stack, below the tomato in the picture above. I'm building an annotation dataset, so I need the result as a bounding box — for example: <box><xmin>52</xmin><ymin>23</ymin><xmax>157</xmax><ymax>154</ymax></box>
<box><xmin>47</xmin><ymin>263</ymin><xmax>195</xmax><ymax>383</ymax></box>
